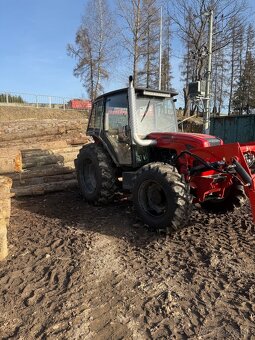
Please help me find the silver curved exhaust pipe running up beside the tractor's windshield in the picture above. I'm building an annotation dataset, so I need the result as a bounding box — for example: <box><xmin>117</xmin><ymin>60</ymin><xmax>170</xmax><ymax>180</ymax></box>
<box><xmin>128</xmin><ymin>76</ymin><xmax>157</xmax><ymax>146</ymax></box>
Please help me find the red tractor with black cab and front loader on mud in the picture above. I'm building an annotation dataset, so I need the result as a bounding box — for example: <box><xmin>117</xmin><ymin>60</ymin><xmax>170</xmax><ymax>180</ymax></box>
<box><xmin>75</xmin><ymin>78</ymin><xmax>255</xmax><ymax>232</ymax></box>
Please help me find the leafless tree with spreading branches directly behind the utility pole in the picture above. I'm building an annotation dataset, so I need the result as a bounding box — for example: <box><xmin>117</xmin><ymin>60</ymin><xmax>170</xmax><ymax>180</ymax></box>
<box><xmin>168</xmin><ymin>0</ymin><xmax>247</xmax><ymax>112</ymax></box>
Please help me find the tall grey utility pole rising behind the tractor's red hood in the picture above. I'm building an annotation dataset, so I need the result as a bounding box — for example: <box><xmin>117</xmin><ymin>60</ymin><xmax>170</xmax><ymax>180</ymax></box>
<box><xmin>203</xmin><ymin>9</ymin><xmax>213</xmax><ymax>134</ymax></box>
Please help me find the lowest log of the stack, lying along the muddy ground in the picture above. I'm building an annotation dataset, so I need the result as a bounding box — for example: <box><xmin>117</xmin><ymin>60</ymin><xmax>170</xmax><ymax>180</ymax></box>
<box><xmin>12</xmin><ymin>179</ymin><xmax>77</xmax><ymax>197</ymax></box>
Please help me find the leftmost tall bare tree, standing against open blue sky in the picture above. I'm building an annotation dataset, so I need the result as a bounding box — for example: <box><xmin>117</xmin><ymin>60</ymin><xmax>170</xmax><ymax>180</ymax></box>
<box><xmin>67</xmin><ymin>0</ymin><xmax>114</xmax><ymax>100</ymax></box>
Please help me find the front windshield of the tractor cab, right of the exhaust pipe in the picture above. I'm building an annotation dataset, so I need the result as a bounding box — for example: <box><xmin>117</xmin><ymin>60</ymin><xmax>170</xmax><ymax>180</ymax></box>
<box><xmin>136</xmin><ymin>95</ymin><xmax>177</xmax><ymax>137</ymax></box>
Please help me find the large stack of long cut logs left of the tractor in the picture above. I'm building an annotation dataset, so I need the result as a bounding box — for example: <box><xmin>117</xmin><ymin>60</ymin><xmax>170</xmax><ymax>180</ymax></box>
<box><xmin>0</xmin><ymin>120</ymin><xmax>89</xmax><ymax>196</ymax></box>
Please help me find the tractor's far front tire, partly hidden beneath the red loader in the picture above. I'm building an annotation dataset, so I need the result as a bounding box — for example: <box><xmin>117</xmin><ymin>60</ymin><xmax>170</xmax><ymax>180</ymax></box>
<box><xmin>201</xmin><ymin>183</ymin><xmax>247</xmax><ymax>213</ymax></box>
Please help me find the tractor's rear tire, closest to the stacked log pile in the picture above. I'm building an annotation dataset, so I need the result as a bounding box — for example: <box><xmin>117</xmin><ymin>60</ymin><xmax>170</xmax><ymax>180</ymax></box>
<box><xmin>75</xmin><ymin>143</ymin><xmax>116</xmax><ymax>204</ymax></box>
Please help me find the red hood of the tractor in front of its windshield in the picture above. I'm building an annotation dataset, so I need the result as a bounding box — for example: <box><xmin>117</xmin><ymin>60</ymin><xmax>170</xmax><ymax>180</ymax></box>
<box><xmin>147</xmin><ymin>132</ymin><xmax>223</xmax><ymax>150</ymax></box>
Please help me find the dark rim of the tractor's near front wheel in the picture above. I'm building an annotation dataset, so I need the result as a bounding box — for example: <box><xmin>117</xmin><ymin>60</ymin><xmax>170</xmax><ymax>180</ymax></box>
<box><xmin>138</xmin><ymin>180</ymin><xmax>167</xmax><ymax>217</ymax></box>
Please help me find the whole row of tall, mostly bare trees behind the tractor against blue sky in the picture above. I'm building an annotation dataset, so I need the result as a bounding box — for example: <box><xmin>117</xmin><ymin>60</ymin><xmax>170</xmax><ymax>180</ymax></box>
<box><xmin>67</xmin><ymin>0</ymin><xmax>255</xmax><ymax>116</ymax></box>
